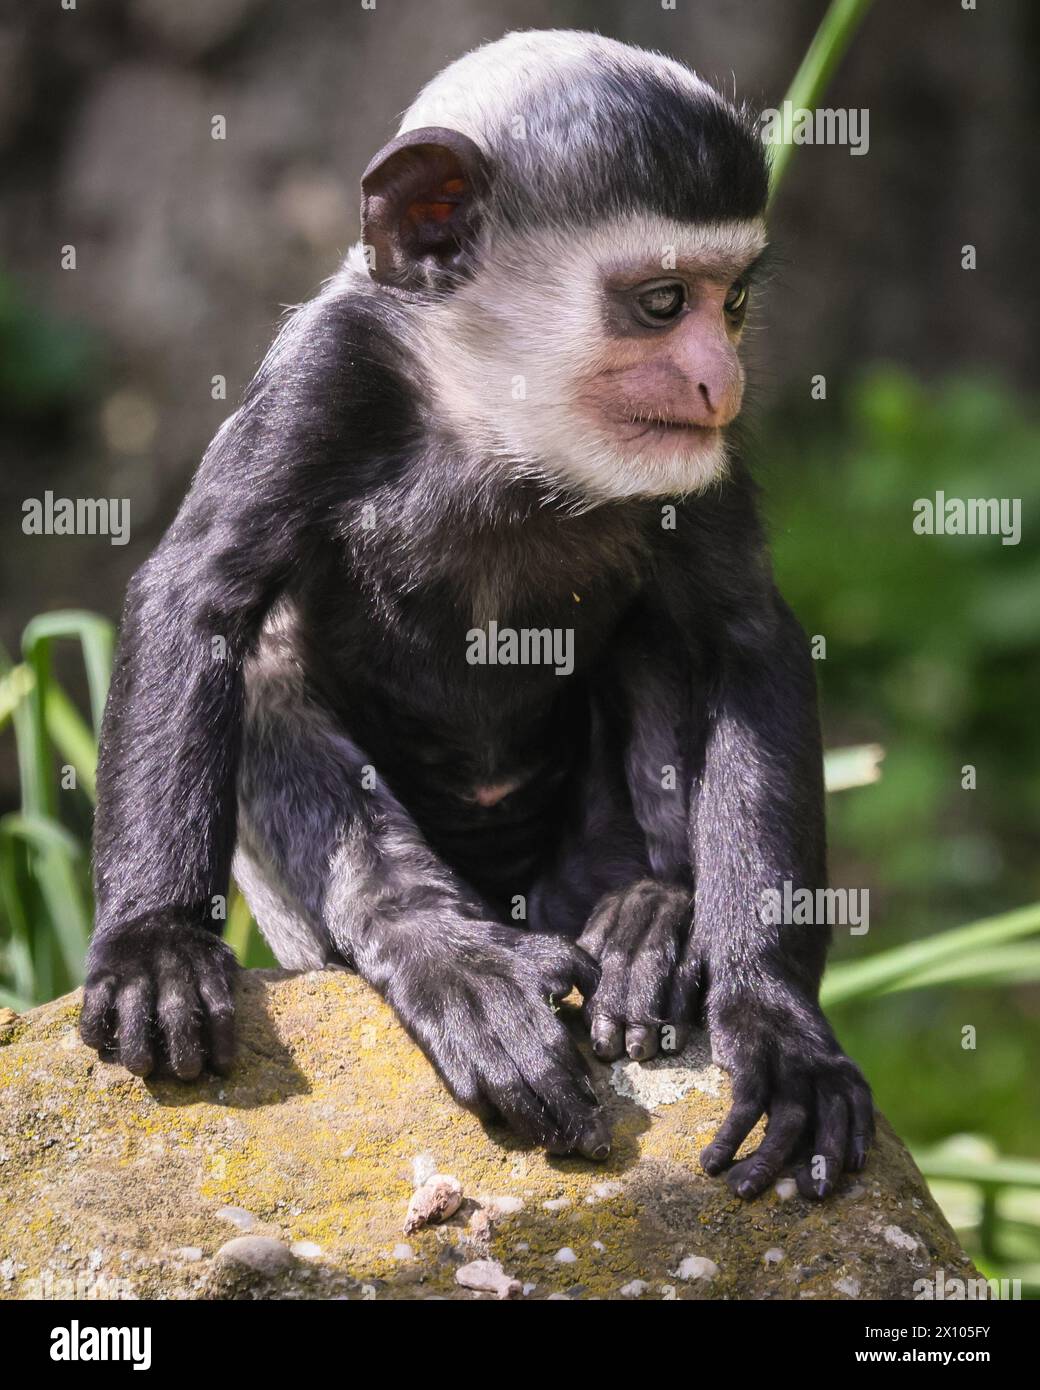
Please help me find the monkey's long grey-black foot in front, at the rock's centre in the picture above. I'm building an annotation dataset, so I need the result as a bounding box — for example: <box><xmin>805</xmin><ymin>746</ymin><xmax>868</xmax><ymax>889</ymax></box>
<box><xmin>387</xmin><ymin>923</ymin><xmax>610</xmax><ymax>1161</ymax></box>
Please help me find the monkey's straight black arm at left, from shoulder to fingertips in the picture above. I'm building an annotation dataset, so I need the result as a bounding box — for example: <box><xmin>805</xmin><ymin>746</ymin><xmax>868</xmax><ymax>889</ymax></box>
<box><xmin>81</xmin><ymin>290</ymin><xmax>358</xmax><ymax>1077</ymax></box>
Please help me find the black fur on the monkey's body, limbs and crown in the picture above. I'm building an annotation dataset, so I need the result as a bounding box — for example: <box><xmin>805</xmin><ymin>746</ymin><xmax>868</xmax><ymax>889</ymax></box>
<box><xmin>82</xmin><ymin>48</ymin><xmax>872</xmax><ymax>1195</ymax></box>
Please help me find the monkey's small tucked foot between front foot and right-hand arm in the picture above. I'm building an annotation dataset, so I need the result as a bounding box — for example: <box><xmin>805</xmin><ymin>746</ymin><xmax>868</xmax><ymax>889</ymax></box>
<box><xmin>578</xmin><ymin>878</ymin><xmax>701</xmax><ymax>1062</ymax></box>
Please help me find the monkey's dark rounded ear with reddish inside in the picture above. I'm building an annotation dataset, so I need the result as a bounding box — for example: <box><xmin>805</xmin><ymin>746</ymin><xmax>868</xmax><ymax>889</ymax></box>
<box><xmin>361</xmin><ymin>125</ymin><xmax>491</xmax><ymax>289</ymax></box>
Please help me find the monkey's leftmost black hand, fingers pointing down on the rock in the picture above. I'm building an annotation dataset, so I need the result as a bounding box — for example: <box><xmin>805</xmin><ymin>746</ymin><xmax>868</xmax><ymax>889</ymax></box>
<box><xmin>79</xmin><ymin>919</ymin><xmax>238</xmax><ymax>1081</ymax></box>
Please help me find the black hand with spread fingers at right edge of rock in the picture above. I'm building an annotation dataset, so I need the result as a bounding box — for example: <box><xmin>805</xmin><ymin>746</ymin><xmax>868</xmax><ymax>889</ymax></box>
<box><xmin>701</xmin><ymin>999</ymin><xmax>875</xmax><ymax>1198</ymax></box>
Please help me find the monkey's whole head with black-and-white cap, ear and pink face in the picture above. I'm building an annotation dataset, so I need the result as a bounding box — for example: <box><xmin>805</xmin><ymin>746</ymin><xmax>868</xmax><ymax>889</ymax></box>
<box><xmin>361</xmin><ymin>31</ymin><xmax>767</xmax><ymax>505</ymax></box>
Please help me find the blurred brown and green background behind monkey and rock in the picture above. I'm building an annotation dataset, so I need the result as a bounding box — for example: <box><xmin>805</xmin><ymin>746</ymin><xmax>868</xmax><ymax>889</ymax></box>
<box><xmin>0</xmin><ymin>0</ymin><xmax>1040</xmax><ymax>1295</ymax></box>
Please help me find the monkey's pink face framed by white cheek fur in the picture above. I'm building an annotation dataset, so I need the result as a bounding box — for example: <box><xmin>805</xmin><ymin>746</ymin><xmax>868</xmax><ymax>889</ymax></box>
<box><xmin>417</xmin><ymin>214</ymin><xmax>765</xmax><ymax>502</ymax></box>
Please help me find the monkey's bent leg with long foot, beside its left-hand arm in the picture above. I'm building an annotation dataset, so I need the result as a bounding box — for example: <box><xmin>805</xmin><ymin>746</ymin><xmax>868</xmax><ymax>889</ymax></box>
<box><xmin>235</xmin><ymin>631</ymin><xmax>609</xmax><ymax>1159</ymax></box>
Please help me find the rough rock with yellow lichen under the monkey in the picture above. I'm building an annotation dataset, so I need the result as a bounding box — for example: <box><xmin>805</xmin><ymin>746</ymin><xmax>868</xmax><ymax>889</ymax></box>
<box><xmin>0</xmin><ymin>972</ymin><xmax>979</xmax><ymax>1301</ymax></box>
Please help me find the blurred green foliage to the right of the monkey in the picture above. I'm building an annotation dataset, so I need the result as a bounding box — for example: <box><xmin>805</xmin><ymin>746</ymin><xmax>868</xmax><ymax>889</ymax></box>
<box><xmin>762</xmin><ymin>367</ymin><xmax>1040</xmax><ymax>1287</ymax></box>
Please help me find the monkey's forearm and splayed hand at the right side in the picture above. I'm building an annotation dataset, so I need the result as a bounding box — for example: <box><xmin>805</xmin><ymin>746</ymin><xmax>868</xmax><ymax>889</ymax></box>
<box><xmin>691</xmin><ymin>592</ymin><xmax>873</xmax><ymax>1197</ymax></box>
